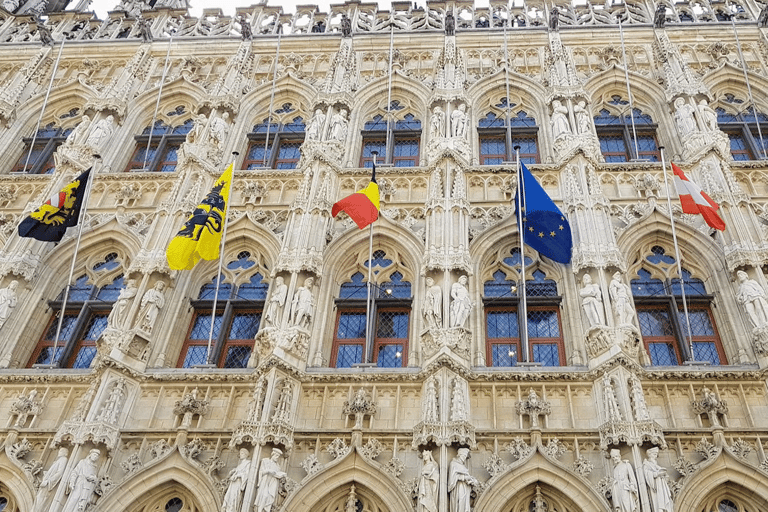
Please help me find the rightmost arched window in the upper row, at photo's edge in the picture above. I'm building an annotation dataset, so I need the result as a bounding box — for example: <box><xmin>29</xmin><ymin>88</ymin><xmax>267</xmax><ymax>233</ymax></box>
<box><xmin>715</xmin><ymin>94</ymin><xmax>768</xmax><ymax>161</ymax></box>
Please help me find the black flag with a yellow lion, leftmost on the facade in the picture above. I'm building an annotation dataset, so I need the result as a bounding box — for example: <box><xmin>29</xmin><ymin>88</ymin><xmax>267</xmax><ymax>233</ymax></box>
<box><xmin>19</xmin><ymin>169</ymin><xmax>91</xmax><ymax>242</ymax></box>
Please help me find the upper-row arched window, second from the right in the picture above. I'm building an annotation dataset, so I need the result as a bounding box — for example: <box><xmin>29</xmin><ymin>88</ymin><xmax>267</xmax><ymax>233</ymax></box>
<box><xmin>594</xmin><ymin>95</ymin><xmax>661</xmax><ymax>162</ymax></box>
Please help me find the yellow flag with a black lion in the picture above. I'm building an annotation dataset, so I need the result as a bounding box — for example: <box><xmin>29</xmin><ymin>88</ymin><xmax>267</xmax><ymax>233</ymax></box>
<box><xmin>170</xmin><ymin>164</ymin><xmax>233</xmax><ymax>270</ymax></box>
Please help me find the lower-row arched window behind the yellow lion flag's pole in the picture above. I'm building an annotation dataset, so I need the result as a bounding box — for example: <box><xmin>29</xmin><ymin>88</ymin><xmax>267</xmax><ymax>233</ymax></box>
<box><xmin>177</xmin><ymin>251</ymin><xmax>269</xmax><ymax>368</ymax></box>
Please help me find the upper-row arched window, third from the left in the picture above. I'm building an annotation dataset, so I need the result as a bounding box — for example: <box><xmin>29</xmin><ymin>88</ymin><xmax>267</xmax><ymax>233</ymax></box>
<box><xmin>243</xmin><ymin>103</ymin><xmax>306</xmax><ymax>169</ymax></box>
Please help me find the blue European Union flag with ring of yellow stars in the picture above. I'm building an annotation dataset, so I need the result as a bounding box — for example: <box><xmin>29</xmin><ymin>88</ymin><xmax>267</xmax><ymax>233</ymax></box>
<box><xmin>515</xmin><ymin>162</ymin><xmax>573</xmax><ymax>264</ymax></box>
